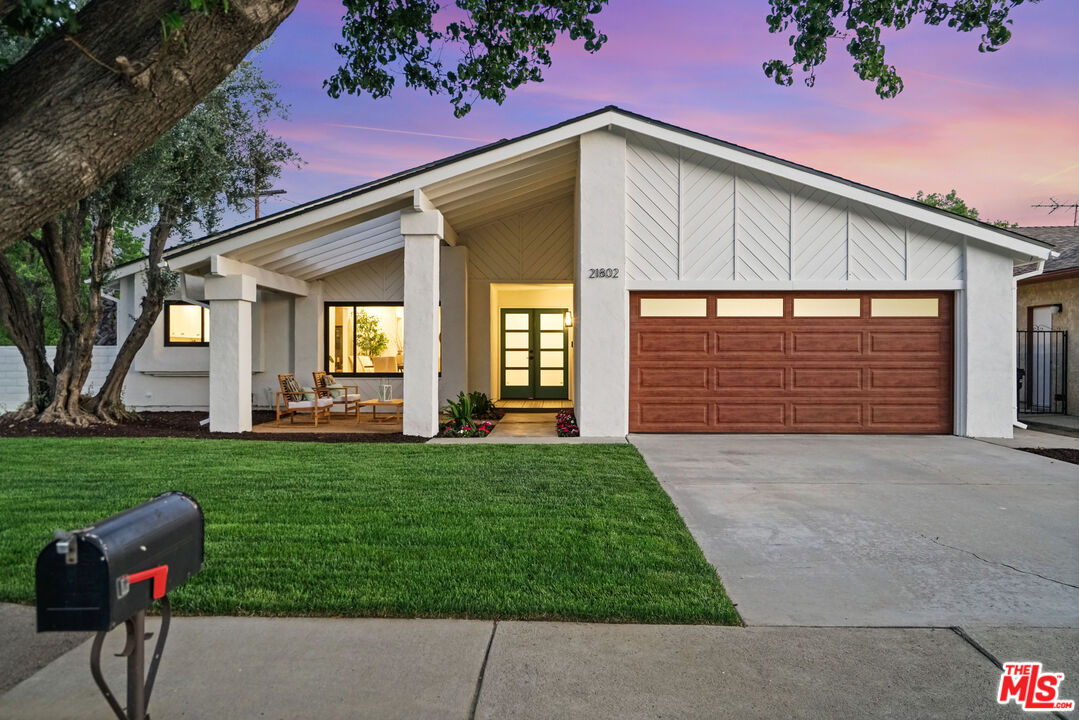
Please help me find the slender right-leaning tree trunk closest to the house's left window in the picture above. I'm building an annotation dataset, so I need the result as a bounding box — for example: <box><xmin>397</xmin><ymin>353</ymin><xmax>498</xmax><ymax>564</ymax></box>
<box><xmin>87</xmin><ymin>207</ymin><xmax>175</xmax><ymax>422</ymax></box>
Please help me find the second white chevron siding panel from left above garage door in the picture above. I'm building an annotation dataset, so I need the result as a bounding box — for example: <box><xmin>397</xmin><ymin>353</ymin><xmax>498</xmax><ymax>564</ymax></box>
<box><xmin>681</xmin><ymin>152</ymin><xmax>735</xmax><ymax>280</ymax></box>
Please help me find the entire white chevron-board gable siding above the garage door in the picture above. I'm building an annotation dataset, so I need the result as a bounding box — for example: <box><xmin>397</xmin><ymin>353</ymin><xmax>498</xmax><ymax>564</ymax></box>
<box><xmin>626</xmin><ymin>134</ymin><xmax>964</xmax><ymax>289</ymax></box>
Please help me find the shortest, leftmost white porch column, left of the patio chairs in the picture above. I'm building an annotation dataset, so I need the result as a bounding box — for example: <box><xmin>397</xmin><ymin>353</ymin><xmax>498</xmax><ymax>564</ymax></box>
<box><xmin>206</xmin><ymin>275</ymin><xmax>256</xmax><ymax>433</ymax></box>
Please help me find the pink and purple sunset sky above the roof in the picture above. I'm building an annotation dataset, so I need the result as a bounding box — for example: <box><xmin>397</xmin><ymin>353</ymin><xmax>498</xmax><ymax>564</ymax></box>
<box><xmin>247</xmin><ymin>0</ymin><xmax>1079</xmax><ymax>225</ymax></box>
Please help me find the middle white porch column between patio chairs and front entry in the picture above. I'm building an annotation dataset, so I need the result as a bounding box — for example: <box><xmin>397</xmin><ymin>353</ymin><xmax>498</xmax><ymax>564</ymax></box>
<box><xmin>401</xmin><ymin>205</ymin><xmax>443</xmax><ymax>437</ymax></box>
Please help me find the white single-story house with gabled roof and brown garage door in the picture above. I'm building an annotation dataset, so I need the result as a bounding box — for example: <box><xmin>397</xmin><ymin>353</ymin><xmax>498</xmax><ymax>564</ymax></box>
<box><xmin>109</xmin><ymin>107</ymin><xmax>1050</xmax><ymax>437</ymax></box>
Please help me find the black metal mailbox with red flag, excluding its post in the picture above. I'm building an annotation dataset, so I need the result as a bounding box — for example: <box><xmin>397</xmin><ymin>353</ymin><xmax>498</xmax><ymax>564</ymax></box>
<box><xmin>37</xmin><ymin>491</ymin><xmax>204</xmax><ymax>633</ymax></box>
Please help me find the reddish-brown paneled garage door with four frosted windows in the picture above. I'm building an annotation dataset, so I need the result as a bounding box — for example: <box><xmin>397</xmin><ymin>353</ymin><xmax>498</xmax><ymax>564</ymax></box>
<box><xmin>629</xmin><ymin>293</ymin><xmax>953</xmax><ymax>433</ymax></box>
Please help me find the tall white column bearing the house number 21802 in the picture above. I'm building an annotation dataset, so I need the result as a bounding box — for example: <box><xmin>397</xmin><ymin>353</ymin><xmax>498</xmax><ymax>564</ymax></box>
<box><xmin>573</xmin><ymin>131</ymin><xmax>629</xmax><ymax>437</ymax></box>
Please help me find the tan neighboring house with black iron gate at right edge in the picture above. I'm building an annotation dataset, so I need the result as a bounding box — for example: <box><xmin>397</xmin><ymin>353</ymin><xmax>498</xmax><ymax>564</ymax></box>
<box><xmin>1015</xmin><ymin>226</ymin><xmax>1079</xmax><ymax>415</ymax></box>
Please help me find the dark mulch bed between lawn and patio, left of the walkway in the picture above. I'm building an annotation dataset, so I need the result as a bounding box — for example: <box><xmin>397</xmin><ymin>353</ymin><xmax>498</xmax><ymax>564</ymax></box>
<box><xmin>0</xmin><ymin>410</ymin><xmax>427</xmax><ymax>443</ymax></box>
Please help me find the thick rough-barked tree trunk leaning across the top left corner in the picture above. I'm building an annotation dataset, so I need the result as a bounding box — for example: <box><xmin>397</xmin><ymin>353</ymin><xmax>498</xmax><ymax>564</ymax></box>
<box><xmin>0</xmin><ymin>0</ymin><xmax>297</xmax><ymax>250</ymax></box>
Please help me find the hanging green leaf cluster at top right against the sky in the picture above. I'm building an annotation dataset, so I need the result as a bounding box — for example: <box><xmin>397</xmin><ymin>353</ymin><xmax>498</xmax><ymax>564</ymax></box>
<box><xmin>764</xmin><ymin>0</ymin><xmax>1039</xmax><ymax>98</ymax></box>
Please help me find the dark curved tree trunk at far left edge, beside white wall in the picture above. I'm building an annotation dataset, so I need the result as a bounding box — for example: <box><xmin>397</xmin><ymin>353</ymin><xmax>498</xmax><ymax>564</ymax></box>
<box><xmin>0</xmin><ymin>246</ymin><xmax>56</xmax><ymax>420</ymax></box>
